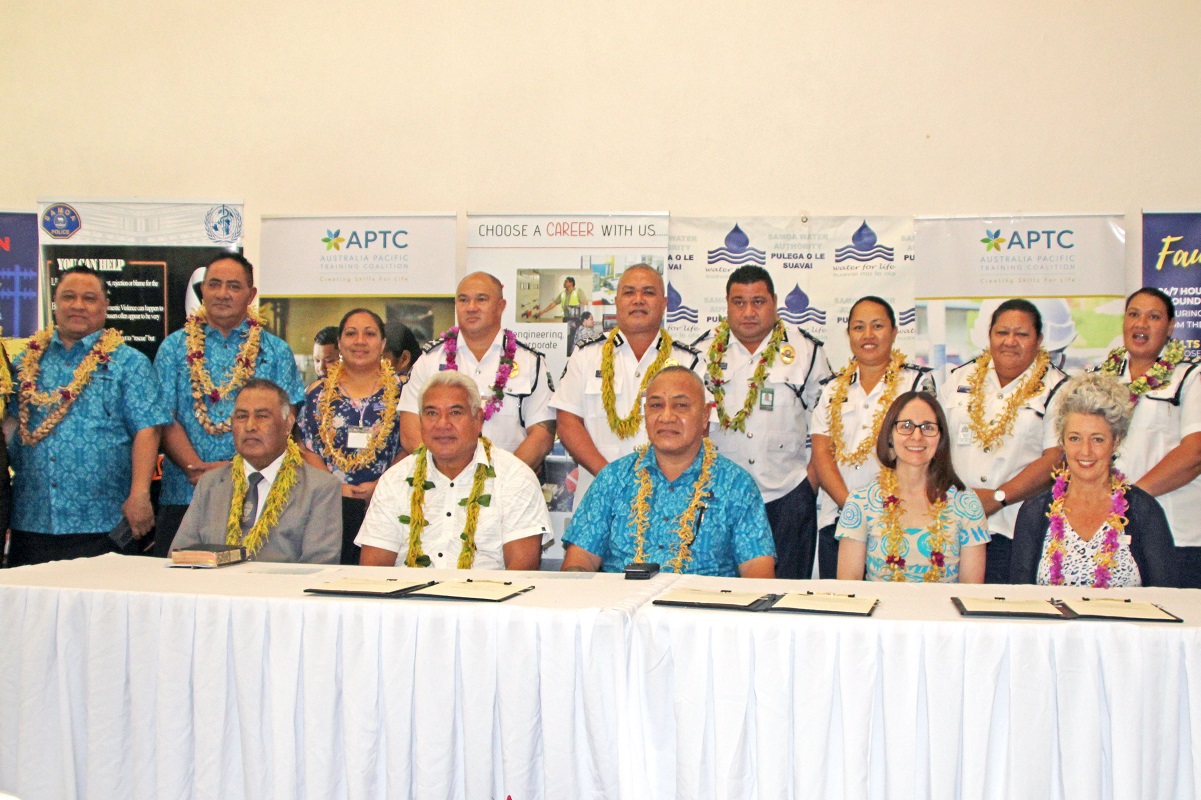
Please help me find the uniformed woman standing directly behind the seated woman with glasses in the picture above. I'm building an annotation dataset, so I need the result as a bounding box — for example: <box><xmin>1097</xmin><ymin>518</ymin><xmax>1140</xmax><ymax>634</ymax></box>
<box><xmin>811</xmin><ymin>295</ymin><xmax>934</xmax><ymax>579</ymax></box>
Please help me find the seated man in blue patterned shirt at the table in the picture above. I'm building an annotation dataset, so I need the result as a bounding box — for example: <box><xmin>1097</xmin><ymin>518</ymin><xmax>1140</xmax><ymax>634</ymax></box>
<box><xmin>563</xmin><ymin>366</ymin><xmax>776</xmax><ymax>578</ymax></box>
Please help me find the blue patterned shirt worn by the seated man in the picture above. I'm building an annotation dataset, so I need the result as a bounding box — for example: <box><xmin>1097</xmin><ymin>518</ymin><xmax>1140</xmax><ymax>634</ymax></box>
<box><xmin>563</xmin><ymin>449</ymin><xmax>776</xmax><ymax>577</ymax></box>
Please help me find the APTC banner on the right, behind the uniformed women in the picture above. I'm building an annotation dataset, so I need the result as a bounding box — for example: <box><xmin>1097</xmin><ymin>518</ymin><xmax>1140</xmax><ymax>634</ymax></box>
<box><xmin>914</xmin><ymin>214</ymin><xmax>1125</xmax><ymax>380</ymax></box>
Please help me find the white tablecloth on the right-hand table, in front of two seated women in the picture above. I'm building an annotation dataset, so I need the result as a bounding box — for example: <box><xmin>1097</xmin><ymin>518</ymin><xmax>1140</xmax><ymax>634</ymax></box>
<box><xmin>629</xmin><ymin>577</ymin><xmax>1201</xmax><ymax>800</ymax></box>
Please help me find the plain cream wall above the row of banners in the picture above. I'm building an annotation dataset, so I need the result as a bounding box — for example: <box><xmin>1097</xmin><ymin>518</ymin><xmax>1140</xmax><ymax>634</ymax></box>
<box><xmin>0</xmin><ymin>0</ymin><xmax>1201</xmax><ymax>283</ymax></box>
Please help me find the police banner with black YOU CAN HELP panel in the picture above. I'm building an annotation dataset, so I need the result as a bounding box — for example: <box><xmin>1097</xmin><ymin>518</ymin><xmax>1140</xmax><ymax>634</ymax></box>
<box><xmin>38</xmin><ymin>199</ymin><xmax>243</xmax><ymax>357</ymax></box>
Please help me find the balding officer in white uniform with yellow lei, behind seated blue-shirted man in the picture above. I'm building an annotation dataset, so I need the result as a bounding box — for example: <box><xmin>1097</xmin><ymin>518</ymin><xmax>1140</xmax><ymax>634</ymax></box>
<box><xmin>550</xmin><ymin>264</ymin><xmax>704</xmax><ymax>502</ymax></box>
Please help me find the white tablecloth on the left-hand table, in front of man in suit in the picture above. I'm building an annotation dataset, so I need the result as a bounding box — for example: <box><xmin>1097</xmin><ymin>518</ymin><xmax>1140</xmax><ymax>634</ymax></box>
<box><xmin>0</xmin><ymin>555</ymin><xmax>671</xmax><ymax>800</ymax></box>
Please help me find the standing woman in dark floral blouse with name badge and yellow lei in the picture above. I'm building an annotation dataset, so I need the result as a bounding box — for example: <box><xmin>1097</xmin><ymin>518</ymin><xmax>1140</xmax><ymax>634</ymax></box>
<box><xmin>299</xmin><ymin>309</ymin><xmax>401</xmax><ymax>563</ymax></box>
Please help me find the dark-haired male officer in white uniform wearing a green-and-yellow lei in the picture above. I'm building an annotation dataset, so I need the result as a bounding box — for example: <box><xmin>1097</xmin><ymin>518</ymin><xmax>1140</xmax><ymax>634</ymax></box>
<box><xmin>693</xmin><ymin>265</ymin><xmax>830</xmax><ymax>578</ymax></box>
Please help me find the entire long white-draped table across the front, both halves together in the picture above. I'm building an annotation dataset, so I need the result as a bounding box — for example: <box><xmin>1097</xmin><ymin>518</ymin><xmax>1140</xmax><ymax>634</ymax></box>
<box><xmin>0</xmin><ymin>555</ymin><xmax>1201</xmax><ymax>800</ymax></box>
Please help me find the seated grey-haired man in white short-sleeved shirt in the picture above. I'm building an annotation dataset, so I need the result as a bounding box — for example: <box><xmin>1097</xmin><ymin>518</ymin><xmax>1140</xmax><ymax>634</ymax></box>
<box><xmin>354</xmin><ymin>371</ymin><xmax>550</xmax><ymax>569</ymax></box>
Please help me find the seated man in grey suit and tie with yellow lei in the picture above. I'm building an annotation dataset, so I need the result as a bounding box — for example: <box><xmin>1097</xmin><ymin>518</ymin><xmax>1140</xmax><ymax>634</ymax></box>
<box><xmin>172</xmin><ymin>378</ymin><xmax>342</xmax><ymax>563</ymax></box>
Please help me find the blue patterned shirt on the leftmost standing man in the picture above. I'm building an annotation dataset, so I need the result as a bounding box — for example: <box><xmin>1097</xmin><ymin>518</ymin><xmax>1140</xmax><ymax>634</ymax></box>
<box><xmin>8</xmin><ymin>330</ymin><xmax>171</xmax><ymax>533</ymax></box>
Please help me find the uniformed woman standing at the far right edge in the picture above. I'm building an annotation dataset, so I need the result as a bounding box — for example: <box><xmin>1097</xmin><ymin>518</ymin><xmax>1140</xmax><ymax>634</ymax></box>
<box><xmin>1100</xmin><ymin>287</ymin><xmax>1201</xmax><ymax>589</ymax></box>
